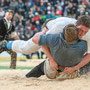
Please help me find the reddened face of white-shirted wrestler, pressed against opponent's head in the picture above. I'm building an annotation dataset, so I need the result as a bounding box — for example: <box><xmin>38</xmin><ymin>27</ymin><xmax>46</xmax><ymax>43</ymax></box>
<box><xmin>77</xmin><ymin>25</ymin><xmax>90</xmax><ymax>39</ymax></box>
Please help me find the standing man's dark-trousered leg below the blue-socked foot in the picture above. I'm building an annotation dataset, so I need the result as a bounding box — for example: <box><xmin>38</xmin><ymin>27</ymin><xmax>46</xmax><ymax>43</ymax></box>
<box><xmin>7</xmin><ymin>50</ymin><xmax>17</xmax><ymax>69</ymax></box>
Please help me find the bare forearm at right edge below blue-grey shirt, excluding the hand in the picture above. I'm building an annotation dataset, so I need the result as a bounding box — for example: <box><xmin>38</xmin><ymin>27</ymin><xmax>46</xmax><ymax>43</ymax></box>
<box><xmin>73</xmin><ymin>54</ymin><xmax>90</xmax><ymax>70</ymax></box>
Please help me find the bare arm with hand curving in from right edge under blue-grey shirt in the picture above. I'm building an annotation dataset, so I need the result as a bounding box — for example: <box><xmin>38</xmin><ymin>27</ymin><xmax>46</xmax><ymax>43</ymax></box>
<box><xmin>64</xmin><ymin>53</ymin><xmax>90</xmax><ymax>74</ymax></box>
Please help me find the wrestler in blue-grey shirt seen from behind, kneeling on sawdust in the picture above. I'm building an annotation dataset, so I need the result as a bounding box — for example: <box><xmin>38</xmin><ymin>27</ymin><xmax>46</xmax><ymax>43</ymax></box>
<box><xmin>26</xmin><ymin>24</ymin><xmax>87</xmax><ymax>80</ymax></box>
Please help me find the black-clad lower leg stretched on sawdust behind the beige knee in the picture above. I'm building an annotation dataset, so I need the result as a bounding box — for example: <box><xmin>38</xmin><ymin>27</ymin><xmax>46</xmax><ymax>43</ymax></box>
<box><xmin>25</xmin><ymin>61</ymin><xmax>45</xmax><ymax>78</ymax></box>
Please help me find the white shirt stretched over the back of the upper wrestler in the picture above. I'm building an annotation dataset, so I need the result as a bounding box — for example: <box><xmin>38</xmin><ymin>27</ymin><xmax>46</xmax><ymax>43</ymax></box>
<box><xmin>46</xmin><ymin>17</ymin><xmax>77</xmax><ymax>34</ymax></box>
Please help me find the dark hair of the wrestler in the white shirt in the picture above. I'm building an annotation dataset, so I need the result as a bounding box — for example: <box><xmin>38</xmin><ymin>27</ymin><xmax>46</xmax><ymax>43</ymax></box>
<box><xmin>76</xmin><ymin>15</ymin><xmax>90</xmax><ymax>28</ymax></box>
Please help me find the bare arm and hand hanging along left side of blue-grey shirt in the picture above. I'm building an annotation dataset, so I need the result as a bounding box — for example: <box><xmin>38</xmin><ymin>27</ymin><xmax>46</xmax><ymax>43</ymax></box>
<box><xmin>41</xmin><ymin>45</ymin><xmax>58</xmax><ymax>69</ymax></box>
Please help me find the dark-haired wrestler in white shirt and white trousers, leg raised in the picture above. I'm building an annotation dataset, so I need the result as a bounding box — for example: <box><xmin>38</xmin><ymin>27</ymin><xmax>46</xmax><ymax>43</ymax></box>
<box><xmin>0</xmin><ymin>15</ymin><xmax>90</xmax><ymax>73</ymax></box>
